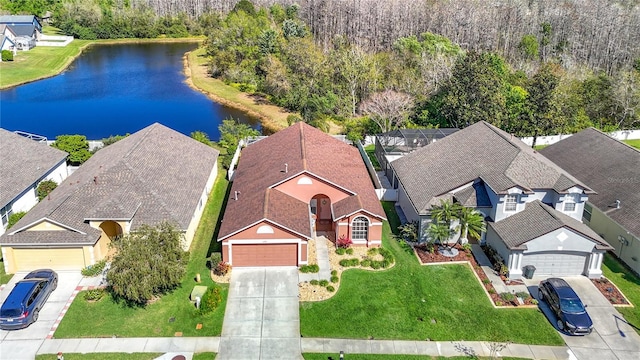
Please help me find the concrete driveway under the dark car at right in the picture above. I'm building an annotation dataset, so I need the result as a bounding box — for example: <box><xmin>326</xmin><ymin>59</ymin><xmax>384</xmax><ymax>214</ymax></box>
<box><xmin>529</xmin><ymin>276</ymin><xmax>640</xmax><ymax>360</ymax></box>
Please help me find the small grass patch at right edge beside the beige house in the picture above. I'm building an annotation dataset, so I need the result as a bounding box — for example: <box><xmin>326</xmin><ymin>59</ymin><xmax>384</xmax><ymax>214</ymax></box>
<box><xmin>602</xmin><ymin>254</ymin><xmax>640</xmax><ymax>334</ymax></box>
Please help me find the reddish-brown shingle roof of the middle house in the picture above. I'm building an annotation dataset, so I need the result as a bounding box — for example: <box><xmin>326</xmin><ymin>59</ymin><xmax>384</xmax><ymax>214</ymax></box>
<box><xmin>218</xmin><ymin>123</ymin><xmax>386</xmax><ymax>241</ymax></box>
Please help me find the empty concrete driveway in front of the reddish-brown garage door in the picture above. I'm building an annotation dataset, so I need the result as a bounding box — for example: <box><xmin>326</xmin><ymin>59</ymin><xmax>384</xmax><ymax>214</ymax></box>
<box><xmin>216</xmin><ymin>267</ymin><xmax>302</xmax><ymax>360</ymax></box>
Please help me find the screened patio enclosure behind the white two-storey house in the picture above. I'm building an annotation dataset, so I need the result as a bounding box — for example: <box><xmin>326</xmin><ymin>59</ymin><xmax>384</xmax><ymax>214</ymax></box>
<box><xmin>375</xmin><ymin>128</ymin><xmax>458</xmax><ymax>188</ymax></box>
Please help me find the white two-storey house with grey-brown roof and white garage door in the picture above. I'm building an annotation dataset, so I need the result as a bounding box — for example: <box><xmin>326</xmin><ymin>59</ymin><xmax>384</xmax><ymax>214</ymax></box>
<box><xmin>391</xmin><ymin>122</ymin><xmax>611</xmax><ymax>277</ymax></box>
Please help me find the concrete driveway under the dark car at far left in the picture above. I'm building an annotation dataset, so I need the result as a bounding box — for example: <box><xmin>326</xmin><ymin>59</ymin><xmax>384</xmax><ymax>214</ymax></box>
<box><xmin>0</xmin><ymin>271</ymin><xmax>82</xmax><ymax>360</ymax></box>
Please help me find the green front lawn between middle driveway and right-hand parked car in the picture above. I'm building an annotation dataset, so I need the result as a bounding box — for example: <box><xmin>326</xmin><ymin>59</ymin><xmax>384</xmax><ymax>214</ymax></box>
<box><xmin>300</xmin><ymin>203</ymin><xmax>564</xmax><ymax>345</ymax></box>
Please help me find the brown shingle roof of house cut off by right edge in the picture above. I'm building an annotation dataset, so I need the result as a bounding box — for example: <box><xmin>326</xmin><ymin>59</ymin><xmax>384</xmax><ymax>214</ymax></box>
<box><xmin>540</xmin><ymin>128</ymin><xmax>640</xmax><ymax>237</ymax></box>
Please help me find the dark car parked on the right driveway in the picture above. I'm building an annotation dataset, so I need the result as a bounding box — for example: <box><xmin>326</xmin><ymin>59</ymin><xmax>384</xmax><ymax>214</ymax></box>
<box><xmin>538</xmin><ymin>278</ymin><xmax>593</xmax><ymax>335</ymax></box>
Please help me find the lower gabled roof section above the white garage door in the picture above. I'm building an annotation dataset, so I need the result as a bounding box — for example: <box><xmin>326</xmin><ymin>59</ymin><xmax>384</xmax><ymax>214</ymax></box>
<box><xmin>488</xmin><ymin>200</ymin><xmax>613</xmax><ymax>250</ymax></box>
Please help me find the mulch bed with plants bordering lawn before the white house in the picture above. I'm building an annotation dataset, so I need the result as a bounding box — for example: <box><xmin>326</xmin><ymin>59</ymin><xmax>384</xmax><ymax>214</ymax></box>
<box><xmin>414</xmin><ymin>245</ymin><xmax>535</xmax><ymax>307</ymax></box>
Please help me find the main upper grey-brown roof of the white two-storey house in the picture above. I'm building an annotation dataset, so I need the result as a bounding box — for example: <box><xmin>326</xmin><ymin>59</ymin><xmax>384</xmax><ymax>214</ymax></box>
<box><xmin>391</xmin><ymin>121</ymin><xmax>592</xmax><ymax>214</ymax></box>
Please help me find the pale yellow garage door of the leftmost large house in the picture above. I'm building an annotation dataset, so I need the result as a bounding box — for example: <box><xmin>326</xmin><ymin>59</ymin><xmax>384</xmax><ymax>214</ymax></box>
<box><xmin>13</xmin><ymin>248</ymin><xmax>85</xmax><ymax>271</ymax></box>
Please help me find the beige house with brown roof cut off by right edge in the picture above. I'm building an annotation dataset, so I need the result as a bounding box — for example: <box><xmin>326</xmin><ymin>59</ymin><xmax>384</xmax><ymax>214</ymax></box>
<box><xmin>540</xmin><ymin>128</ymin><xmax>640</xmax><ymax>274</ymax></box>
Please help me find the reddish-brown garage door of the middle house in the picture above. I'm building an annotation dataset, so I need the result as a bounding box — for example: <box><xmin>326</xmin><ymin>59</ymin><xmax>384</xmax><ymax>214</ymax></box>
<box><xmin>231</xmin><ymin>244</ymin><xmax>298</xmax><ymax>267</ymax></box>
